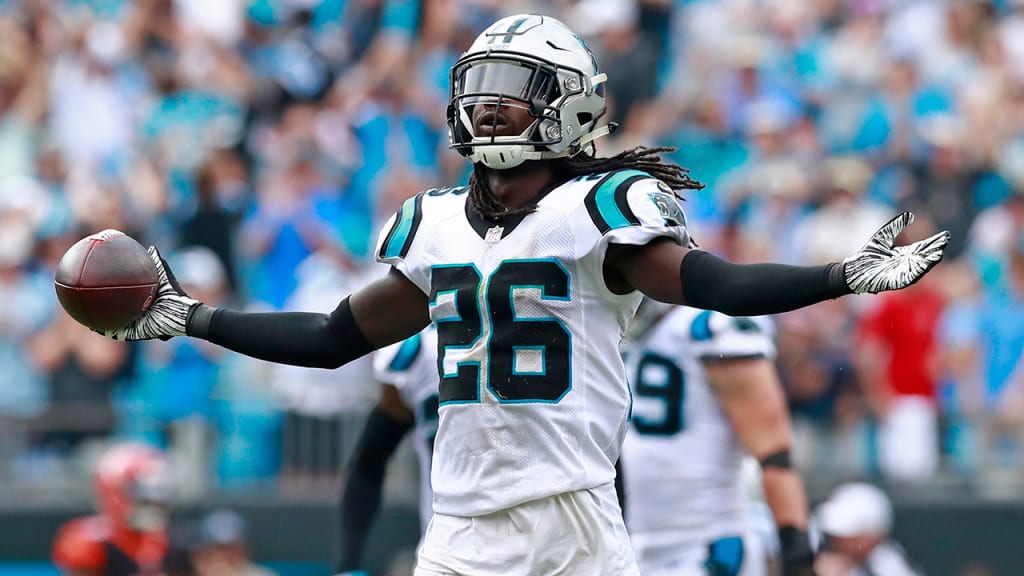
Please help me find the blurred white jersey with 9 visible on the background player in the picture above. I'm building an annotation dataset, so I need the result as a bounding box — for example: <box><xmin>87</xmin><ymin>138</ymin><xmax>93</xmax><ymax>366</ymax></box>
<box><xmin>623</xmin><ymin>307</ymin><xmax>775</xmax><ymax>554</ymax></box>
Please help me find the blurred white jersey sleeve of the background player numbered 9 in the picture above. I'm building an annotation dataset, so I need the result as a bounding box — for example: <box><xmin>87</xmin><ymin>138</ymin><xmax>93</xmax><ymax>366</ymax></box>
<box><xmin>689</xmin><ymin>311</ymin><xmax>775</xmax><ymax>360</ymax></box>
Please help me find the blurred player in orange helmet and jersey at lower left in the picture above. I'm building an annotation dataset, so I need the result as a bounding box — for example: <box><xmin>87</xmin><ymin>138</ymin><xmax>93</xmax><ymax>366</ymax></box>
<box><xmin>52</xmin><ymin>444</ymin><xmax>188</xmax><ymax>576</ymax></box>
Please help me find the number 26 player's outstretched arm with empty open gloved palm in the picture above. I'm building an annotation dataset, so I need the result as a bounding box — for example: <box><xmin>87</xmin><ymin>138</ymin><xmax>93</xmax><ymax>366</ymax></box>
<box><xmin>605</xmin><ymin>212</ymin><xmax>949</xmax><ymax>316</ymax></box>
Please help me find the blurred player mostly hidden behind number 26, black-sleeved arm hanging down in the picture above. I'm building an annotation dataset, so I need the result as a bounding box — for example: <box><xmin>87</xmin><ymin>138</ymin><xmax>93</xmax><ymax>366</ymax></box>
<box><xmin>335</xmin><ymin>327</ymin><xmax>437</xmax><ymax>576</ymax></box>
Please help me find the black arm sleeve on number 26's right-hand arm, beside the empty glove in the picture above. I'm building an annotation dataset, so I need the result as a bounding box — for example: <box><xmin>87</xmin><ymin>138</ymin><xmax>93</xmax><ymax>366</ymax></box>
<box><xmin>679</xmin><ymin>250</ymin><xmax>852</xmax><ymax>316</ymax></box>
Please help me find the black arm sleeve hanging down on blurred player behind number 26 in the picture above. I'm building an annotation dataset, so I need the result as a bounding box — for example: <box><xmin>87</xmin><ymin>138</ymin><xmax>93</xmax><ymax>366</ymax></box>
<box><xmin>335</xmin><ymin>408</ymin><xmax>413</xmax><ymax>573</ymax></box>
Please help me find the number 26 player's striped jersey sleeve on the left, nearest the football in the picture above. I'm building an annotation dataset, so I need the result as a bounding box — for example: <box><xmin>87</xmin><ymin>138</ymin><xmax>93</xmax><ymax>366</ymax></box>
<box><xmin>375</xmin><ymin>194</ymin><xmax>430</xmax><ymax>294</ymax></box>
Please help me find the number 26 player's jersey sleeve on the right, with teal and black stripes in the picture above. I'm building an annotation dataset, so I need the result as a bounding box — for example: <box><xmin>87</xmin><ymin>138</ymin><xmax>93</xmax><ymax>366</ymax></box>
<box><xmin>585</xmin><ymin>170</ymin><xmax>690</xmax><ymax>246</ymax></box>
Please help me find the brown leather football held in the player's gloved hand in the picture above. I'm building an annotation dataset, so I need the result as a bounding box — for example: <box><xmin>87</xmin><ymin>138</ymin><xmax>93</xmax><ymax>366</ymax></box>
<box><xmin>53</xmin><ymin>230</ymin><xmax>160</xmax><ymax>331</ymax></box>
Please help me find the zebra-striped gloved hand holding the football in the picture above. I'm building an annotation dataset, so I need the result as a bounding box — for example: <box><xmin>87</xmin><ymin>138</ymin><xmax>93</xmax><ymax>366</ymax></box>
<box><xmin>103</xmin><ymin>246</ymin><xmax>200</xmax><ymax>340</ymax></box>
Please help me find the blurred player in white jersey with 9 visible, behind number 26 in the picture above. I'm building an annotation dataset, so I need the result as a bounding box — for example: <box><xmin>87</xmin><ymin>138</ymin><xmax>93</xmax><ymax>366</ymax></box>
<box><xmin>623</xmin><ymin>300</ymin><xmax>814</xmax><ymax>576</ymax></box>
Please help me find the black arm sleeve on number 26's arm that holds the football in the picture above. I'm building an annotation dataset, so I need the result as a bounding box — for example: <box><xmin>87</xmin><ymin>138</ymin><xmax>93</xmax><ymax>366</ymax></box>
<box><xmin>186</xmin><ymin>298</ymin><xmax>374</xmax><ymax>368</ymax></box>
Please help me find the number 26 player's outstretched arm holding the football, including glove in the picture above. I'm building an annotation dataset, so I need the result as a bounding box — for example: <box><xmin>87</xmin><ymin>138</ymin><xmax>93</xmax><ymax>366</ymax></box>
<box><xmin>99</xmin><ymin>247</ymin><xmax>430</xmax><ymax>368</ymax></box>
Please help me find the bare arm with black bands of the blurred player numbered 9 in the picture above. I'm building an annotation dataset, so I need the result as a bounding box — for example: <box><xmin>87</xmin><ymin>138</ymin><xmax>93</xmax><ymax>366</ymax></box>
<box><xmin>705</xmin><ymin>358</ymin><xmax>814</xmax><ymax>576</ymax></box>
